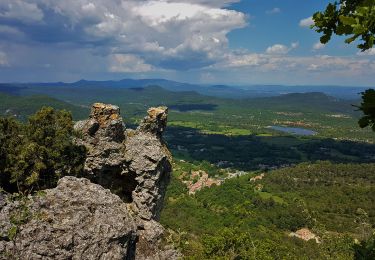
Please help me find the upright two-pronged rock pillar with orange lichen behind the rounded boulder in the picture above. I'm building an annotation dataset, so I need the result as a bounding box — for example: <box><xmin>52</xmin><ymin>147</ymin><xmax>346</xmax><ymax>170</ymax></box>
<box><xmin>75</xmin><ymin>103</ymin><xmax>171</xmax><ymax>220</ymax></box>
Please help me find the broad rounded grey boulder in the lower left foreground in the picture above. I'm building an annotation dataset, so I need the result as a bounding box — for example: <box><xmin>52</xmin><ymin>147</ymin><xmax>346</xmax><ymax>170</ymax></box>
<box><xmin>0</xmin><ymin>177</ymin><xmax>137</xmax><ymax>259</ymax></box>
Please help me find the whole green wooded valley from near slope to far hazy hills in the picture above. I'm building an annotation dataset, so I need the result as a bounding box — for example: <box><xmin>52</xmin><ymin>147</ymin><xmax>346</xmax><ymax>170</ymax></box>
<box><xmin>0</xmin><ymin>86</ymin><xmax>375</xmax><ymax>259</ymax></box>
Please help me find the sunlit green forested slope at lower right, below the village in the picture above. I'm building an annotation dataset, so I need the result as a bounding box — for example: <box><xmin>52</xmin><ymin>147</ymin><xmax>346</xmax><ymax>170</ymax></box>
<box><xmin>161</xmin><ymin>161</ymin><xmax>375</xmax><ymax>259</ymax></box>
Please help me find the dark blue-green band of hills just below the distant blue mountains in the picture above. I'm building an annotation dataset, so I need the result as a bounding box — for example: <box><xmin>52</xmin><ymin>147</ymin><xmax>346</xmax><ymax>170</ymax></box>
<box><xmin>0</xmin><ymin>84</ymin><xmax>359</xmax><ymax>113</ymax></box>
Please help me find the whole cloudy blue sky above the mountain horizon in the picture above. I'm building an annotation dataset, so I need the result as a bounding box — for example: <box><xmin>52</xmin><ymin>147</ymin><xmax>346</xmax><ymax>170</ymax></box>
<box><xmin>0</xmin><ymin>0</ymin><xmax>375</xmax><ymax>86</ymax></box>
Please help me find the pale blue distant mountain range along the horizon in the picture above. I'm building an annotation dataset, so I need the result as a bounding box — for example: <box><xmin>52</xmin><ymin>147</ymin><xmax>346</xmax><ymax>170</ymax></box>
<box><xmin>0</xmin><ymin>79</ymin><xmax>367</xmax><ymax>100</ymax></box>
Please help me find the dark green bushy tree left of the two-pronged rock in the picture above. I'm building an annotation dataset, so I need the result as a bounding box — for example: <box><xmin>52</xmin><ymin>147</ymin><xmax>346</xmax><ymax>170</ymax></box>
<box><xmin>0</xmin><ymin>107</ymin><xmax>85</xmax><ymax>194</ymax></box>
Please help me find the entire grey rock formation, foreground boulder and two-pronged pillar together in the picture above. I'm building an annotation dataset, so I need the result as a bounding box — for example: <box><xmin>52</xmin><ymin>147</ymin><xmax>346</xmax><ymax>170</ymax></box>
<box><xmin>0</xmin><ymin>103</ymin><xmax>179</xmax><ymax>259</ymax></box>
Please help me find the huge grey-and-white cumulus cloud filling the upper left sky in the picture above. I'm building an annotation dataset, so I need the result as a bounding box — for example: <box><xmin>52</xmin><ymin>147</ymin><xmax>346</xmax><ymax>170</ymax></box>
<box><xmin>0</xmin><ymin>0</ymin><xmax>247</xmax><ymax>70</ymax></box>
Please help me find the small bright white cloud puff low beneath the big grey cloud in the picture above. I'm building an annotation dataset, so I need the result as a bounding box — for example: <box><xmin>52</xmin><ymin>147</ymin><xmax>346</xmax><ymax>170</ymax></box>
<box><xmin>110</xmin><ymin>54</ymin><xmax>153</xmax><ymax>73</ymax></box>
